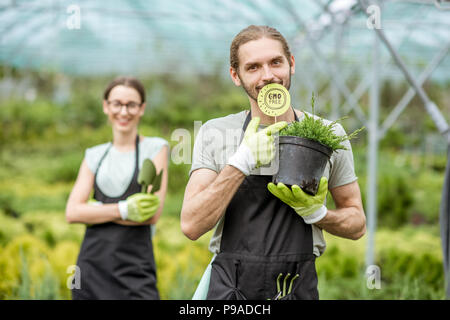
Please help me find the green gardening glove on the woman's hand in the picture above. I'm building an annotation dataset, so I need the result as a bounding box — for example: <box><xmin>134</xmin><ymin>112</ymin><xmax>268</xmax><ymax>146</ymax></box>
<box><xmin>119</xmin><ymin>193</ymin><xmax>159</xmax><ymax>222</ymax></box>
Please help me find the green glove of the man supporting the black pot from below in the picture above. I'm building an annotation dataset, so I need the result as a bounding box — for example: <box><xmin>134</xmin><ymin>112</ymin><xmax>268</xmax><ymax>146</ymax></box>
<box><xmin>267</xmin><ymin>177</ymin><xmax>328</xmax><ymax>224</ymax></box>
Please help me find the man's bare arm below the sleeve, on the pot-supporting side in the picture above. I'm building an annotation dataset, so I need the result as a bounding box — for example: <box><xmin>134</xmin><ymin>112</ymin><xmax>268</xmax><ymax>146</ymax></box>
<box><xmin>315</xmin><ymin>181</ymin><xmax>366</xmax><ymax>240</ymax></box>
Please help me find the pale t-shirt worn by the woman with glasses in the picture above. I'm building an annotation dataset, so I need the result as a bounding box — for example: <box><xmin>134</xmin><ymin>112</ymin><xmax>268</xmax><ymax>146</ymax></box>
<box><xmin>85</xmin><ymin>137</ymin><xmax>169</xmax><ymax>197</ymax></box>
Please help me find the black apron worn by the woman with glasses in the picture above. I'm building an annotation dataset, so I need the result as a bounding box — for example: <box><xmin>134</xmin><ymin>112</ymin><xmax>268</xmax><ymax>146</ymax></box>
<box><xmin>72</xmin><ymin>136</ymin><xmax>159</xmax><ymax>300</ymax></box>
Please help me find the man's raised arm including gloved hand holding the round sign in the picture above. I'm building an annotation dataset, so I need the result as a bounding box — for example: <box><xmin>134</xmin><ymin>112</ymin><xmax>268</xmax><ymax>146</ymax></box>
<box><xmin>181</xmin><ymin>117</ymin><xmax>287</xmax><ymax>240</ymax></box>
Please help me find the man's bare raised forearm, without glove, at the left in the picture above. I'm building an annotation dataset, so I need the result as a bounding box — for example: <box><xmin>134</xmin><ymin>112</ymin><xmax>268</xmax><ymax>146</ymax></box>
<box><xmin>181</xmin><ymin>165</ymin><xmax>245</xmax><ymax>240</ymax></box>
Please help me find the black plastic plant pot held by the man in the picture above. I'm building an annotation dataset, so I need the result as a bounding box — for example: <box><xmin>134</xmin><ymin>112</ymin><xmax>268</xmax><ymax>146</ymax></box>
<box><xmin>272</xmin><ymin>136</ymin><xmax>333</xmax><ymax>195</ymax></box>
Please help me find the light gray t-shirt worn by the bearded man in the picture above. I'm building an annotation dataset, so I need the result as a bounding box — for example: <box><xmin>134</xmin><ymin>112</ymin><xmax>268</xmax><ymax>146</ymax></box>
<box><xmin>189</xmin><ymin>111</ymin><xmax>357</xmax><ymax>256</ymax></box>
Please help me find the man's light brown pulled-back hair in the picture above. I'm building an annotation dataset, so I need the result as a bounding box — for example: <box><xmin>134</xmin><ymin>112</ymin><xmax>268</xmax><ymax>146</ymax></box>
<box><xmin>230</xmin><ymin>25</ymin><xmax>291</xmax><ymax>71</ymax></box>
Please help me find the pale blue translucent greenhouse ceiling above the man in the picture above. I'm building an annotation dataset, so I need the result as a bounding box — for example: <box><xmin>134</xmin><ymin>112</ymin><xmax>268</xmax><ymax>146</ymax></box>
<box><xmin>0</xmin><ymin>0</ymin><xmax>450</xmax><ymax>81</ymax></box>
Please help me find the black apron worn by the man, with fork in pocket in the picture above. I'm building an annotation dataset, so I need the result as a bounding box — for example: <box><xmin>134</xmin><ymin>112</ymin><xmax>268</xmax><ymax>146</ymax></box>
<box><xmin>207</xmin><ymin>112</ymin><xmax>319</xmax><ymax>300</ymax></box>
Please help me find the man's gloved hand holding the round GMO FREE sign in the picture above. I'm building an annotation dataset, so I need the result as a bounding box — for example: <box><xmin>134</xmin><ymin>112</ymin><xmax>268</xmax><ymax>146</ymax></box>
<box><xmin>228</xmin><ymin>117</ymin><xmax>287</xmax><ymax>176</ymax></box>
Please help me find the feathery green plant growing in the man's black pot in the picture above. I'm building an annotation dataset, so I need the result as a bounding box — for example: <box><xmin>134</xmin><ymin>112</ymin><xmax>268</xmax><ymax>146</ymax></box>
<box><xmin>280</xmin><ymin>93</ymin><xmax>364</xmax><ymax>151</ymax></box>
